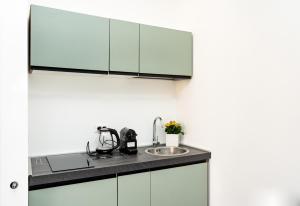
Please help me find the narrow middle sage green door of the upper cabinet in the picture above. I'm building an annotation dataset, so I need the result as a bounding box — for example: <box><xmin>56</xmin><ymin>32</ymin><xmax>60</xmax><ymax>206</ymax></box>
<box><xmin>110</xmin><ymin>19</ymin><xmax>139</xmax><ymax>73</ymax></box>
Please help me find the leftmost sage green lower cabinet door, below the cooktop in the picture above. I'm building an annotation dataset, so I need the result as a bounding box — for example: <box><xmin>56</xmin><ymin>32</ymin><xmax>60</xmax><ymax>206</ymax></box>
<box><xmin>28</xmin><ymin>178</ymin><xmax>117</xmax><ymax>206</ymax></box>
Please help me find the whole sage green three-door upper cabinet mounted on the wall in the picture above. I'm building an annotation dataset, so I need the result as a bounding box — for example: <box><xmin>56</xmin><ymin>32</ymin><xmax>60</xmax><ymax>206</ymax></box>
<box><xmin>30</xmin><ymin>5</ymin><xmax>193</xmax><ymax>79</ymax></box>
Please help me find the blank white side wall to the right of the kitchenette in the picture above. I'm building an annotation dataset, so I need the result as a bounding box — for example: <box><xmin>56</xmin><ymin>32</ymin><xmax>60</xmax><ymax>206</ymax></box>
<box><xmin>177</xmin><ymin>0</ymin><xmax>300</xmax><ymax>206</ymax></box>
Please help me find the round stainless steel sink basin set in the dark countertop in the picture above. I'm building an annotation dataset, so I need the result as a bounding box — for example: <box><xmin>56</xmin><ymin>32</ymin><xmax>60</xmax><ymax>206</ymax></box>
<box><xmin>145</xmin><ymin>147</ymin><xmax>190</xmax><ymax>156</ymax></box>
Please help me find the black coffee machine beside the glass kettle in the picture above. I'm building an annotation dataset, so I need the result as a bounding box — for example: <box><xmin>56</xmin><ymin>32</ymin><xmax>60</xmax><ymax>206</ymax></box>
<box><xmin>119</xmin><ymin>127</ymin><xmax>137</xmax><ymax>154</ymax></box>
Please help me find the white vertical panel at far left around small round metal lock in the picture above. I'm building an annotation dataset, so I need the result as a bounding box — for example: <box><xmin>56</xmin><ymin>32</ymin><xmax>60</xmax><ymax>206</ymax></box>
<box><xmin>0</xmin><ymin>0</ymin><xmax>29</xmax><ymax>206</ymax></box>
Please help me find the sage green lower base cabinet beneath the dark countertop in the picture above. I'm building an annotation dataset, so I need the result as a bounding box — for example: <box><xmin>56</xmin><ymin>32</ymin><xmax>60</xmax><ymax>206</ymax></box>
<box><xmin>29</xmin><ymin>163</ymin><xmax>208</xmax><ymax>206</ymax></box>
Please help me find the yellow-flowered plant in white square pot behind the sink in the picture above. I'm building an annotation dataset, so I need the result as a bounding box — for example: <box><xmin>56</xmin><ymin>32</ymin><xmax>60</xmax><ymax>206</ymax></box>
<box><xmin>165</xmin><ymin>121</ymin><xmax>184</xmax><ymax>147</ymax></box>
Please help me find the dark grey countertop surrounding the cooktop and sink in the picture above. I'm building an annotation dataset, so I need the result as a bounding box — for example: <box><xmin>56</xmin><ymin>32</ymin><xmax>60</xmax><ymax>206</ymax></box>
<box><xmin>28</xmin><ymin>145</ymin><xmax>211</xmax><ymax>190</ymax></box>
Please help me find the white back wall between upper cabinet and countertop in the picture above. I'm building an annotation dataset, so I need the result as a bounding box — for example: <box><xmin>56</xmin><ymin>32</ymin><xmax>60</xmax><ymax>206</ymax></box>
<box><xmin>29</xmin><ymin>71</ymin><xmax>176</xmax><ymax>155</ymax></box>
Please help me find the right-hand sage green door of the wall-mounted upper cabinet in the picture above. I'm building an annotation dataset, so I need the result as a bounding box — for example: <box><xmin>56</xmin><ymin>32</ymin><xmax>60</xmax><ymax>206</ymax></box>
<box><xmin>140</xmin><ymin>25</ymin><xmax>193</xmax><ymax>76</ymax></box>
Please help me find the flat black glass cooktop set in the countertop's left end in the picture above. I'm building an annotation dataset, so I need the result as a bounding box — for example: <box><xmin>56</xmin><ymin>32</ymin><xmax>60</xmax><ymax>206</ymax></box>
<box><xmin>47</xmin><ymin>153</ymin><xmax>93</xmax><ymax>172</ymax></box>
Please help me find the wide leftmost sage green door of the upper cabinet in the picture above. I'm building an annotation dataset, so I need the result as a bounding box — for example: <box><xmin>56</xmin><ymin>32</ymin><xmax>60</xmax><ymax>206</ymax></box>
<box><xmin>30</xmin><ymin>6</ymin><xmax>109</xmax><ymax>71</ymax></box>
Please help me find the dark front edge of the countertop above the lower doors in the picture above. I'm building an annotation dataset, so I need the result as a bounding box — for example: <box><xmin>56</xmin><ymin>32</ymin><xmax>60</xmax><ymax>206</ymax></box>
<box><xmin>28</xmin><ymin>146</ymin><xmax>211</xmax><ymax>191</ymax></box>
